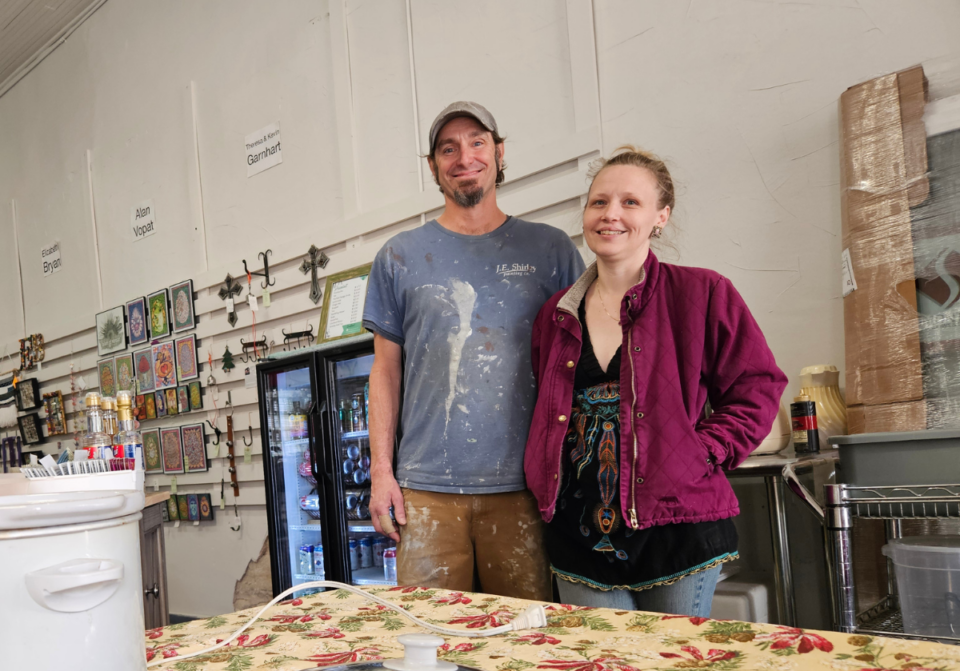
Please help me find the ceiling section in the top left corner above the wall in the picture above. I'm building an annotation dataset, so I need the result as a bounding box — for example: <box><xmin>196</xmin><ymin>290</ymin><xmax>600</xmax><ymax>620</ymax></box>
<box><xmin>0</xmin><ymin>0</ymin><xmax>103</xmax><ymax>95</ymax></box>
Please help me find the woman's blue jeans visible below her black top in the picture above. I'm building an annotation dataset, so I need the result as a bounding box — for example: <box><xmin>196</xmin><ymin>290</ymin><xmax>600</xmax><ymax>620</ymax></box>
<box><xmin>557</xmin><ymin>566</ymin><xmax>723</xmax><ymax>617</ymax></box>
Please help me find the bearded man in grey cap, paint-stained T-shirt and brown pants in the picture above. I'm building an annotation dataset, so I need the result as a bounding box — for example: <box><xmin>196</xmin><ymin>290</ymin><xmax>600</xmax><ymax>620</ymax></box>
<box><xmin>363</xmin><ymin>102</ymin><xmax>584</xmax><ymax>600</ymax></box>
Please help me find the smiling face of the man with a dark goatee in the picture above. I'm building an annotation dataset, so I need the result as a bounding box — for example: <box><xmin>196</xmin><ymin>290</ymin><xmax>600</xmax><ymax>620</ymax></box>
<box><xmin>429</xmin><ymin>117</ymin><xmax>503</xmax><ymax>207</ymax></box>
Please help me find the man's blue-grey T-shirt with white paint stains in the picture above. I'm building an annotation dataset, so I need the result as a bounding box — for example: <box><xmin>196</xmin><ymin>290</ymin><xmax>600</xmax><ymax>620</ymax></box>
<box><xmin>363</xmin><ymin>217</ymin><xmax>584</xmax><ymax>494</ymax></box>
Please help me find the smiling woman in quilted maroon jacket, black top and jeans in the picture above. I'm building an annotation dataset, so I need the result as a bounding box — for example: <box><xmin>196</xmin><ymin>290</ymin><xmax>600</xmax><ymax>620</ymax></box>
<box><xmin>524</xmin><ymin>147</ymin><xmax>786</xmax><ymax>617</ymax></box>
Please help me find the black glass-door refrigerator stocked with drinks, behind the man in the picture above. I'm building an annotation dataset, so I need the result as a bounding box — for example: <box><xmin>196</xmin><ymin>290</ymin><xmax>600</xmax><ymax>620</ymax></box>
<box><xmin>257</xmin><ymin>335</ymin><xmax>396</xmax><ymax>595</ymax></box>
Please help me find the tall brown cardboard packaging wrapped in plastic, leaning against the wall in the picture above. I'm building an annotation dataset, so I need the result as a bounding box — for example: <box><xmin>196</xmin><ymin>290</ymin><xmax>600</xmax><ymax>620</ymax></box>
<box><xmin>840</xmin><ymin>67</ymin><xmax>929</xmax><ymax>406</ymax></box>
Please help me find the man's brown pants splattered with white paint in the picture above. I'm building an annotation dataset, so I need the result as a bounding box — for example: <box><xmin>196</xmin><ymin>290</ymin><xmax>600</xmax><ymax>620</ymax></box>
<box><xmin>397</xmin><ymin>489</ymin><xmax>552</xmax><ymax>601</ymax></box>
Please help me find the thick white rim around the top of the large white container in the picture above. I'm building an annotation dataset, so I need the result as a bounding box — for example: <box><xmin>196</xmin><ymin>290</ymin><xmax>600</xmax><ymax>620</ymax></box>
<box><xmin>0</xmin><ymin>490</ymin><xmax>144</xmax><ymax>530</ymax></box>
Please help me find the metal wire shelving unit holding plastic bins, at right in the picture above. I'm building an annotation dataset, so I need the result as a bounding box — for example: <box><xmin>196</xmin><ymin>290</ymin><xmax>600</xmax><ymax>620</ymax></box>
<box><xmin>783</xmin><ymin>465</ymin><xmax>960</xmax><ymax>643</ymax></box>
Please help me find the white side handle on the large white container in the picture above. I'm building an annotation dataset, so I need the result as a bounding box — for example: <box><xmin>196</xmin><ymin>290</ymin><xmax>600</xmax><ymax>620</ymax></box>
<box><xmin>24</xmin><ymin>559</ymin><xmax>123</xmax><ymax>613</ymax></box>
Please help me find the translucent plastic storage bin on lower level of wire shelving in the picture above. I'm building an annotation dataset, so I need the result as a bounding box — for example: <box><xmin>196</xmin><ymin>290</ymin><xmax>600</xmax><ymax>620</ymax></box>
<box><xmin>883</xmin><ymin>536</ymin><xmax>960</xmax><ymax>637</ymax></box>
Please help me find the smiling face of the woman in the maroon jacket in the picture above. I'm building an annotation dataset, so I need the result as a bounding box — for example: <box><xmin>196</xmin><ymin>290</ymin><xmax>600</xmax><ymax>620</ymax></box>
<box><xmin>583</xmin><ymin>165</ymin><xmax>670</xmax><ymax>261</ymax></box>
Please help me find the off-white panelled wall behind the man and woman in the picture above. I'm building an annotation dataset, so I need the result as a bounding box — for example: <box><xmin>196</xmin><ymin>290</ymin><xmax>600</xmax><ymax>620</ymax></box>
<box><xmin>0</xmin><ymin>0</ymin><xmax>960</xmax><ymax>615</ymax></box>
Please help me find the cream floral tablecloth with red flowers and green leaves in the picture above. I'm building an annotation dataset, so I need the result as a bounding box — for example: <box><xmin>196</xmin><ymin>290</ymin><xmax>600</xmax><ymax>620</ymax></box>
<box><xmin>146</xmin><ymin>587</ymin><xmax>960</xmax><ymax>671</ymax></box>
